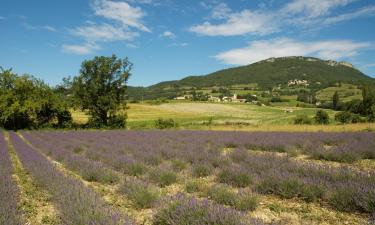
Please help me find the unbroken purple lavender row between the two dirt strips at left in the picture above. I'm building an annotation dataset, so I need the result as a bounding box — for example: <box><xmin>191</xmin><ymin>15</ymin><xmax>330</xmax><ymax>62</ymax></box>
<box><xmin>10</xmin><ymin>132</ymin><xmax>131</xmax><ymax>225</ymax></box>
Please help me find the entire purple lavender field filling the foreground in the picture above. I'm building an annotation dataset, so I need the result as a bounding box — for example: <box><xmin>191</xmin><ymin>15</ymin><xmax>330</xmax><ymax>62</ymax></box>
<box><xmin>0</xmin><ymin>131</ymin><xmax>375</xmax><ymax>224</ymax></box>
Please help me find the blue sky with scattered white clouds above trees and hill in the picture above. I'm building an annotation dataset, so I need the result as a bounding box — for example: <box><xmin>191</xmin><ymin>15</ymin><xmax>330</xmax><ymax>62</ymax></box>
<box><xmin>0</xmin><ymin>0</ymin><xmax>375</xmax><ymax>86</ymax></box>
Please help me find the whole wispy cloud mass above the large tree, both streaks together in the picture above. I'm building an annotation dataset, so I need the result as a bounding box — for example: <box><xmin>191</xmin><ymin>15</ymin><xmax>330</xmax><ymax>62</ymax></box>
<box><xmin>62</xmin><ymin>0</ymin><xmax>152</xmax><ymax>55</ymax></box>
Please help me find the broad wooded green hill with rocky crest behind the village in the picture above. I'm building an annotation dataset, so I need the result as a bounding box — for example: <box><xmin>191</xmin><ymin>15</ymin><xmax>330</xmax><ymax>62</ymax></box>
<box><xmin>129</xmin><ymin>56</ymin><xmax>375</xmax><ymax>98</ymax></box>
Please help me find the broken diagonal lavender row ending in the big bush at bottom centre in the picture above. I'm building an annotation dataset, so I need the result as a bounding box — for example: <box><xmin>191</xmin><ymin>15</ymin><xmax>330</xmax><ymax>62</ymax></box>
<box><xmin>22</xmin><ymin>133</ymin><xmax>264</xmax><ymax>225</ymax></box>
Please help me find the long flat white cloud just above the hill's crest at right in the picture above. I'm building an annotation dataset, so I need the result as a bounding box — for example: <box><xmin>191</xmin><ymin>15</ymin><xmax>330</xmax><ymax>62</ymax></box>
<box><xmin>215</xmin><ymin>38</ymin><xmax>370</xmax><ymax>65</ymax></box>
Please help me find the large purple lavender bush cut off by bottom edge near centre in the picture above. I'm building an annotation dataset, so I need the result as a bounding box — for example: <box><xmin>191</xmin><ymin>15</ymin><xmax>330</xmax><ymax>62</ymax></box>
<box><xmin>152</xmin><ymin>196</ymin><xmax>250</xmax><ymax>225</ymax></box>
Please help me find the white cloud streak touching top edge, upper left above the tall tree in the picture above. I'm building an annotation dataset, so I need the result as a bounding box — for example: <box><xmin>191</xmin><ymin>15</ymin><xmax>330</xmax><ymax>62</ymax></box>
<box><xmin>92</xmin><ymin>0</ymin><xmax>151</xmax><ymax>32</ymax></box>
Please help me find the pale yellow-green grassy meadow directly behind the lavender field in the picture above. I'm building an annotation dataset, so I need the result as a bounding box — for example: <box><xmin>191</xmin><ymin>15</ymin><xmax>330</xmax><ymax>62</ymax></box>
<box><xmin>72</xmin><ymin>101</ymin><xmax>375</xmax><ymax>132</ymax></box>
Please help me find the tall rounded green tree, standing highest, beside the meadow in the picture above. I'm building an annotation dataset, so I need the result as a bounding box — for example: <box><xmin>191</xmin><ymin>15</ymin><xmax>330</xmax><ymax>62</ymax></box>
<box><xmin>73</xmin><ymin>55</ymin><xmax>133</xmax><ymax>127</ymax></box>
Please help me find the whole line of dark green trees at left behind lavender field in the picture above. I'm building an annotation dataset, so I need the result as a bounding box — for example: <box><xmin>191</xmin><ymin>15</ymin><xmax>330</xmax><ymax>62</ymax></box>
<box><xmin>0</xmin><ymin>55</ymin><xmax>133</xmax><ymax>130</ymax></box>
